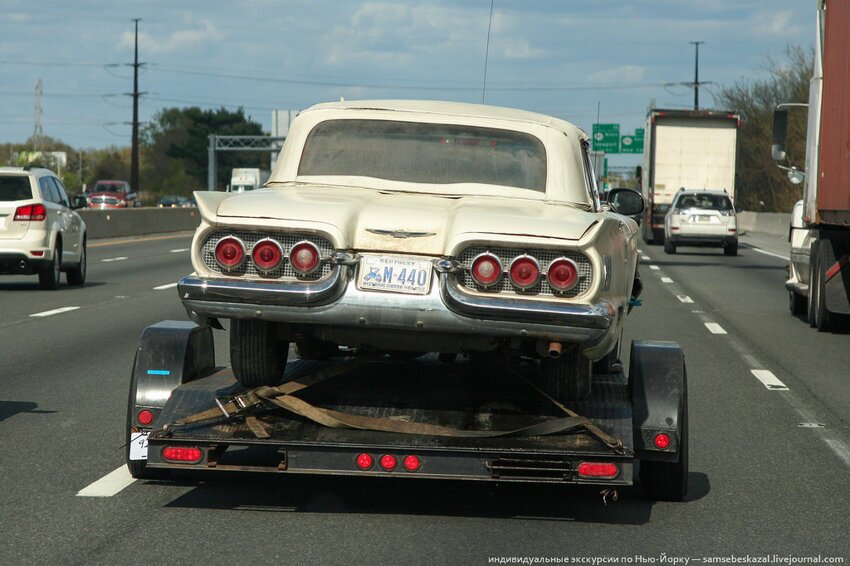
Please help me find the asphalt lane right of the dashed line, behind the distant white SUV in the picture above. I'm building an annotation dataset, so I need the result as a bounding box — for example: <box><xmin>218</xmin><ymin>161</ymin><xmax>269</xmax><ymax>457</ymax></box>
<box><xmin>643</xmin><ymin>246</ymin><xmax>850</xmax><ymax>426</ymax></box>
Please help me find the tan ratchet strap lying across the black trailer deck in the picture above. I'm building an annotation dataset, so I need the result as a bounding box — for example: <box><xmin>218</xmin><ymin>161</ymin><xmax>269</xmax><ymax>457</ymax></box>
<box><xmin>156</xmin><ymin>353</ymin><xmax>623</xmax><ymax>453</ymax></box>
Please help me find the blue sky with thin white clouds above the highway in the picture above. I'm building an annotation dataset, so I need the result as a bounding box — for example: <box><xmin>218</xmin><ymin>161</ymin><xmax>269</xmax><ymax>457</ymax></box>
<box><xmin>0</xmin><ymin>0</ymin><xmax>815</xmax><ymax>165</ymax></box>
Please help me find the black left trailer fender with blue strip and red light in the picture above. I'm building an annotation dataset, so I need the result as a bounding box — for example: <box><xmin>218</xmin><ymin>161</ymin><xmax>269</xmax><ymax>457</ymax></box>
<box><xmin>125</xmin><ymin>320</ymin><xmax>215</xmax><ymax>478</ymax></box>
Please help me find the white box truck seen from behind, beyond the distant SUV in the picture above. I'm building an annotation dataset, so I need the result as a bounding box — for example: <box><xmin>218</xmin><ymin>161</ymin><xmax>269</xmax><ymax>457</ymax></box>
<box><xmin>639</xmin><ymin>108</ymin><xmax>741</xmax><ymax>244</ymax></box>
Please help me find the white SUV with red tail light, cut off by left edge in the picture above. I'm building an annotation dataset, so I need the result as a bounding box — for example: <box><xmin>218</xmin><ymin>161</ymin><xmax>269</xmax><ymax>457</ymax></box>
<box><xmin>0</xmin><ymin>167</ymin><xmax>86</xmax><ymax>289</ymax></box>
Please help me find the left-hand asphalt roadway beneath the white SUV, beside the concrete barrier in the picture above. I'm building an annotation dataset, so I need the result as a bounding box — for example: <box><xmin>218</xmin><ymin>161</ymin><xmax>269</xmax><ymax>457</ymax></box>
<box><xmin>0</xmin><ymin>236</ymin><xmax>192</xmax><ymax>327</ymax></box>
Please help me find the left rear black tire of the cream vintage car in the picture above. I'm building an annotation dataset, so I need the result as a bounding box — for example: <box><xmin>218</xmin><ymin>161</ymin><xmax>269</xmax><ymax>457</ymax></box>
<box><xmin>230</xmin><ymin>319</ymin><xmax>289</xmax><ymax>387</ymax></box>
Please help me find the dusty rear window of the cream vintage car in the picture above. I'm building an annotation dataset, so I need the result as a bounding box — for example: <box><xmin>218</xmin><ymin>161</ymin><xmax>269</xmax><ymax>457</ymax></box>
<box><xmin>298</xmin><ymin>120</ymin><xmax>546</xmax><ymax>192</ymax></box>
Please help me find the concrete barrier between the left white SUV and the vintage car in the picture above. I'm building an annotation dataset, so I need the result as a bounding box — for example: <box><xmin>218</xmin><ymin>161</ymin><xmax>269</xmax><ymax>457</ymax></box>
<box><xmin>77</xmin><ymin>208</ymin><xmax>201</xmax><ymax>240</ymax></box>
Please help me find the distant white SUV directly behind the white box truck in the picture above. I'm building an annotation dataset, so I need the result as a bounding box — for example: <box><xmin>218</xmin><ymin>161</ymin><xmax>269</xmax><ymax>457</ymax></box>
<box><xmin>664</xmin><ymin>189</ymin><xmax>738</xmax><ymax>255</ymax></box>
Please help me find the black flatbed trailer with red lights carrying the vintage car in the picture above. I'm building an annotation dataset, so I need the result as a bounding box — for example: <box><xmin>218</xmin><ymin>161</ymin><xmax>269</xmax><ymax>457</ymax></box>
<box><xmin>126</xmin><ymin>321</ymin><xmax>688</xmax><ymax>500</ymax></box>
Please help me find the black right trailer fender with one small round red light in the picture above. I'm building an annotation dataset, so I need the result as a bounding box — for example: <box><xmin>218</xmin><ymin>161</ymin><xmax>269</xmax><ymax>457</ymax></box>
<box><xmin>629</xmin><ymin>340</ymin><xmax>687</xmax><ymax>462</ymax></box>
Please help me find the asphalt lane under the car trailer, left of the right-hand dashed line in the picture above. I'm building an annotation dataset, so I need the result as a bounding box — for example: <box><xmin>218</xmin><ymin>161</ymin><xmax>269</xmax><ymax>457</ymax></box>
<box><xmin>16</xmin><ymin>274</ymin><xmax>850</xmax><ymax>563</ymax></box>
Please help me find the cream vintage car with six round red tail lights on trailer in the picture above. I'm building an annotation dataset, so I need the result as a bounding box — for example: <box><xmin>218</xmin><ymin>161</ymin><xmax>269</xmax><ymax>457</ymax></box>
<box><xmin>178</xmin><ymin>101</ymin><xmax>643</xmax><ymax>399</ymax></box>
